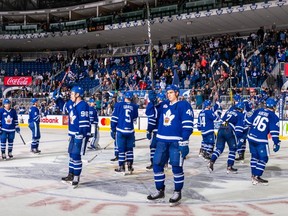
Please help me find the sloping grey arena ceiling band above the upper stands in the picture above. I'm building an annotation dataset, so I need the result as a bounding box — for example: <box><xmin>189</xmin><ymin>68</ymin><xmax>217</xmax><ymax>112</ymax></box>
<box><xmin>0</xmin><ymin>3</ymin><xmax>288</xmax><ymax>51</ymax></box>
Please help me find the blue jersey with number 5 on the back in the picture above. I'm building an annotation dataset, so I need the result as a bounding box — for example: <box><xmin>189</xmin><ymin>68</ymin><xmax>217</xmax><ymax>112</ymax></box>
<box><xmin>111</xmin><ymin>102</ymin><xmax>138</xmax><ymax>133</ymax></box>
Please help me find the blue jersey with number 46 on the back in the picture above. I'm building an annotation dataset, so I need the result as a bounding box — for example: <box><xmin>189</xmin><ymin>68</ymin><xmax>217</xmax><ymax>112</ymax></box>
<box><xmin>246</xmin><ymin>108</ymin><xmax>280</xmax><ymax>144</ymax></box>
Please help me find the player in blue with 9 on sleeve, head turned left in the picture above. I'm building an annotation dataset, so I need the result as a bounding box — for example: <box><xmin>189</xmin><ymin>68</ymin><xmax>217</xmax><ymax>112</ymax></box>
<box><xmin>62</xmin><ymin>86</ymin><xmax>91</xmax><ymax>188</ymax></box>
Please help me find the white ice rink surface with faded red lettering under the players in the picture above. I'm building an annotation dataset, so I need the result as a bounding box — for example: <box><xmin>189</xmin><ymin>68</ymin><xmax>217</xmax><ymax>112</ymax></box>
<box><xmin>0</xmin><ymin>127</ymin><xmax>288</xmax><ymax>216</ymax></box>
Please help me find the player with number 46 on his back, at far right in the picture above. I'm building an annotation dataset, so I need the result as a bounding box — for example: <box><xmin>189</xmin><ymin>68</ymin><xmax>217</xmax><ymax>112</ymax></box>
<box><xmin>247</xmin><ymin>98</ymin><xmax>280</xmax><ymax>185</ymax></box>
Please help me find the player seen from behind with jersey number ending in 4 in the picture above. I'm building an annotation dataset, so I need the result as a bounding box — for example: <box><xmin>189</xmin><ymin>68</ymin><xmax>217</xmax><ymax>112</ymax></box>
<box><xmin>197</xmin><ymin>100</ymin><xmax>217</xmax><ymax>160</ymax></box>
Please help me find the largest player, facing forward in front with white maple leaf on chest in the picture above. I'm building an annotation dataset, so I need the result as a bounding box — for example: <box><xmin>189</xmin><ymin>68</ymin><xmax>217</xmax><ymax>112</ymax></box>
<box><xmin>147</xmin><ymin>85</ymin><xmax>194</xmax><ymax>206</ymax></box>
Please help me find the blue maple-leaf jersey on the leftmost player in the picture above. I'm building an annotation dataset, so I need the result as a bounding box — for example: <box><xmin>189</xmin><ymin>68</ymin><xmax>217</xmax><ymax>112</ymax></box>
<box><xmin>0</xmin><ymin>108</ymin><xmax>19</xmax><ymax>132</ymax></box>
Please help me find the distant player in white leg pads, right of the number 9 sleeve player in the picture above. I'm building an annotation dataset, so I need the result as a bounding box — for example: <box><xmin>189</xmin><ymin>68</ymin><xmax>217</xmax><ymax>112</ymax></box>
<box><xmin>87</xmin><ymin>98</ymin><xmax>100</xmax><ymax>150</ymax></box>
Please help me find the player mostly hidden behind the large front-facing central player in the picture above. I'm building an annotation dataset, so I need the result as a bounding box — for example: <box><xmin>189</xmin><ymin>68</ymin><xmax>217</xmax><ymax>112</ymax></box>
<box><xmin>145</xmin><ymin>91</ymin><xmax>166</xmax><ymax>170</ymax></box>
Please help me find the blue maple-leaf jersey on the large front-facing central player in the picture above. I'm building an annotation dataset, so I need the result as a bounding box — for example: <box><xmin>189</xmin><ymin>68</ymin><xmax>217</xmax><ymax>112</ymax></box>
<box><xmin>155</xmin><ymin>101</ymin><xmax>194</xmax><ymax>142</ymax></box>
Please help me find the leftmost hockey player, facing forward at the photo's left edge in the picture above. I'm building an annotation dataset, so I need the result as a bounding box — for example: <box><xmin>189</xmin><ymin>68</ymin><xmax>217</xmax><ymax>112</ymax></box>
<box><xmin>0</xmin><ymin>99</ymin><xmax>20</xmax><ymax>160</ymax></box>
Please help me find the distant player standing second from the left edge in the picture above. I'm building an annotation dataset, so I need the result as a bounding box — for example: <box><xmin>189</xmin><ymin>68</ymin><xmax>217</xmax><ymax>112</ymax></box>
<box><xmin>28</xmin><ymin>98</ymin><xmax>41</xmax><ymax>154</ymax></box>
